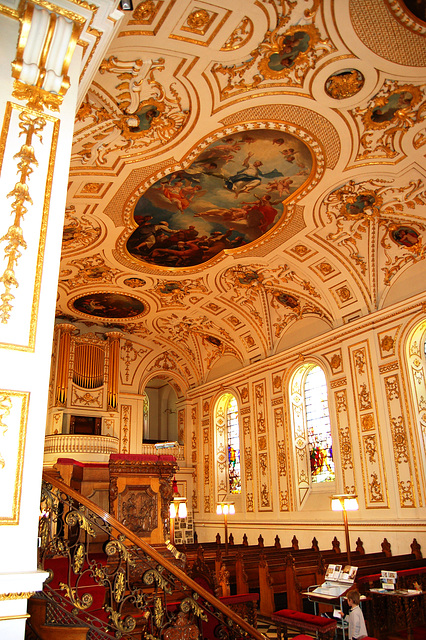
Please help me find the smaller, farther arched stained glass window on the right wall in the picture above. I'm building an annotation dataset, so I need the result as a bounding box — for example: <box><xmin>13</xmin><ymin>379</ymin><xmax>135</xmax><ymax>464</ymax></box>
<box><xmin>215</xmin><ymin>393</ymin><xmax>241</xmax><ymax>499</ymax></box>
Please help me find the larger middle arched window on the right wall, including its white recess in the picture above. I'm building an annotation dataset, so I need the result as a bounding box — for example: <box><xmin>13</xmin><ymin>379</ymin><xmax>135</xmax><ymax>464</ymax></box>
<box><xmin>290</xmin><ymin>362</ymin><xmax>335</xmax><ymax>506</ymax></box>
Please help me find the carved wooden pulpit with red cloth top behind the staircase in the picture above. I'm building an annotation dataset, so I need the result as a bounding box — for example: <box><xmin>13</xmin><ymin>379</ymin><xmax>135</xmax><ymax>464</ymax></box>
<box><xmin>109</xmin><ymin>454</ymin><xmax>178</xmax><ymax>544</ymax></box>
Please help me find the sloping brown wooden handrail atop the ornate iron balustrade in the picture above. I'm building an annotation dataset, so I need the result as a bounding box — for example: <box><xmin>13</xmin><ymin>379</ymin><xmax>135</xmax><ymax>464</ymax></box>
<box><xmin>43</xmin><ymin>470</ymin><xmax>265</xmax><ymax>640</ymax></box>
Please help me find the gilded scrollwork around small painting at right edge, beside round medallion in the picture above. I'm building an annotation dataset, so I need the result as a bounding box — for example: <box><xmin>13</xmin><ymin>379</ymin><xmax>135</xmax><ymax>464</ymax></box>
<box><xmin>352</xmin><ymin>80</ymin><xmax>426</xmax><ymax>160</ymax></box>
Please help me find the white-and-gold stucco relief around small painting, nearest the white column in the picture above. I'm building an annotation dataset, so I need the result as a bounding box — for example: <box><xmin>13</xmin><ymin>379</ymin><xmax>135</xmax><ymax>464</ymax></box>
<box><xmin>72</xmin><ymin>56</ymin><xmax>189</xmax><ymax>166</ymax></box>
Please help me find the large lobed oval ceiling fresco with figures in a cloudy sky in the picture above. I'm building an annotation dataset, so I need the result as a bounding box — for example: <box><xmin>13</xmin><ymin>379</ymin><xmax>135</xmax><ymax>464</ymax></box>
<box><xmin>127</xmin><ymin>129</ymin><xmax>313</xmax><ymax>268</ymax></box>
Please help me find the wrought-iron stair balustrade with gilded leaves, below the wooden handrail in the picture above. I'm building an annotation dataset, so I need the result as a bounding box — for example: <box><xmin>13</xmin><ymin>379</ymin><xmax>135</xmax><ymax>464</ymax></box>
<box><xmin>39</xmin><ymin>478</ymin><xmax>260</xmax><ymax>640</ymax></box>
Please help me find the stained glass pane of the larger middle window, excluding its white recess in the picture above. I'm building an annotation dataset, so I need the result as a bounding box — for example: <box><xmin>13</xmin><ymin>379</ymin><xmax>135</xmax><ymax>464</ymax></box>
<box><xmin>305</xmin><ymin>366</ymin><xmax>335</xmax><ymax>482</ymax></box>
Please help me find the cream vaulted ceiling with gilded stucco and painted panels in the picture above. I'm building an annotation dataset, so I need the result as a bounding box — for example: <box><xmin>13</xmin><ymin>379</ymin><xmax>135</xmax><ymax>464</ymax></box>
<box><xmin>57</xmin><ymin>0</ymin><xmax>426</xmax><ymax>385</ymax></box>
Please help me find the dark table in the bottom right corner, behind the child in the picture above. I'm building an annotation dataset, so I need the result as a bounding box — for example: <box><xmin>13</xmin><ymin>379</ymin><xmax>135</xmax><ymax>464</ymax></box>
<box><xmin>368</xmin><ymin>589</ymin><xmax>426</xmax><ymax>640</ymax></box>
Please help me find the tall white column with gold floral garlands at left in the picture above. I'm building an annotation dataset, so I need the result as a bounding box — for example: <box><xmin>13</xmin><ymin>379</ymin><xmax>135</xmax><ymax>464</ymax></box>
<box><xmin>0</xmin><ymin>0</ymin><xmax>120</xmax><ymax>640</ymax></box>
